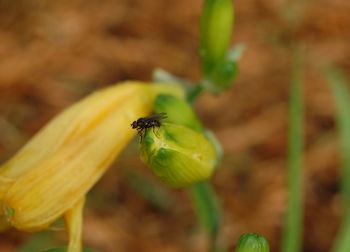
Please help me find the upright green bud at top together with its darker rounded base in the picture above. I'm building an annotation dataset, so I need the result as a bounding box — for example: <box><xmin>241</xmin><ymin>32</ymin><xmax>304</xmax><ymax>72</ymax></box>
<box><xmin>199</xmin><ymin>0</ymin><xmax>241</xmax><ymax>94</ymax></box>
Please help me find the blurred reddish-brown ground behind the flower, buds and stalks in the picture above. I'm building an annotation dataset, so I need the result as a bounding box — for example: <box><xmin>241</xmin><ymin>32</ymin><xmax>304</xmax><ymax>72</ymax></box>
<box><xmin>0</xmin><ymin>0</ymin><xmax>350</xmax><ymax>252</ymax></box>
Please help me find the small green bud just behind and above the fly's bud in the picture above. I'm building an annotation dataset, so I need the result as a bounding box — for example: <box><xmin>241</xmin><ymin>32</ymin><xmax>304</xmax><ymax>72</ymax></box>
<box><xmin>154</xmin><ymin>95</ymin><xmax>203</xmax><ymax>132</ymax></box>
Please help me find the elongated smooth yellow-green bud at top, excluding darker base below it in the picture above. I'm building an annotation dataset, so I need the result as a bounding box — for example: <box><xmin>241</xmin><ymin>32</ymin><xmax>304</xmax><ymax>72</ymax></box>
<box><xmin>200</xmin><ymin>0</ymin><xmax>234</xmax><ymax>68</ymax></box>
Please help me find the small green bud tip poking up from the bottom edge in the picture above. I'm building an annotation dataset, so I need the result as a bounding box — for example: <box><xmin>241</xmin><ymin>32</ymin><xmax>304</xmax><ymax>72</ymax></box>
<box><xmin>236</xmin><ymin>233</ymin><xmax>270</xmax><ymax>252</ymax></box>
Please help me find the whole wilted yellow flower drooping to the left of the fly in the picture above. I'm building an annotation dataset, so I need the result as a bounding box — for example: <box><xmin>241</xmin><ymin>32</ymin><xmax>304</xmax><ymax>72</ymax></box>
<box><xmin>0</xmin><ymin>82</ymin><xmax>184</xmax><ymax>248</ymax></box>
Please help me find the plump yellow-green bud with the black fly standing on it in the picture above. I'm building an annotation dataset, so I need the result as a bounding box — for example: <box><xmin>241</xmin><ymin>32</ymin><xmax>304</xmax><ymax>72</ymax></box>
<box><xmin>141</xmin><ymin>123</ymin><xmax>216</xmax><ymax>187</ymax></box>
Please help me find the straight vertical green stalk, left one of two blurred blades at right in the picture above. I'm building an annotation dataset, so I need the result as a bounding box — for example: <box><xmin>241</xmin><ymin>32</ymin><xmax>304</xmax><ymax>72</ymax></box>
<box><xmin>282</xmin><ymin>48</ymin><xmax>304</xmax><ymax>252</ymax></box>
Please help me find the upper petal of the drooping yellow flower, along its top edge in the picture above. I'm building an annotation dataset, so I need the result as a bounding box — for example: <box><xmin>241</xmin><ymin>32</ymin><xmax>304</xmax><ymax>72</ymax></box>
<box><xmin>0</xmin><ymin>81</ymin><xmax>184</xmax><ymax>182</ymax></box>
